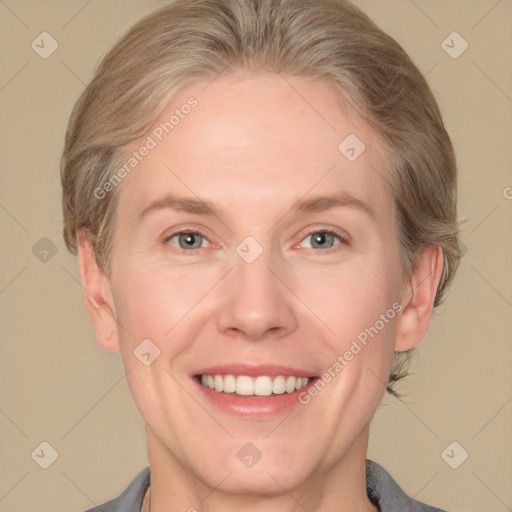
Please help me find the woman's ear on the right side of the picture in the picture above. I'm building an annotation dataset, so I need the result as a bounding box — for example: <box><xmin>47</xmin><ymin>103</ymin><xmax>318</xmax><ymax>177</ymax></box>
<box><xmin>395</xmin><ymin>245</ymin><xmax>443</xmax><ymax>352</ymax></box>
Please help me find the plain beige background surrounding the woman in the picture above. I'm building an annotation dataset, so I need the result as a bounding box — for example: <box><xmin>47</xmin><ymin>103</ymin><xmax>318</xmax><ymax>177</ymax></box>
<box><xmin>0</xmin><ymin>0</ymin><xmax>512</xmax><ymax>512</ymax></box>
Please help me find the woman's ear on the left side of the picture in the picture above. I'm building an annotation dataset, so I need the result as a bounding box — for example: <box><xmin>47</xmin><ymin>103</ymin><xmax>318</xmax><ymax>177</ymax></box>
<box><xmin>78</xmin><ymin>230</ymin><xmax>119</xmax><ymax>351</ymax></box>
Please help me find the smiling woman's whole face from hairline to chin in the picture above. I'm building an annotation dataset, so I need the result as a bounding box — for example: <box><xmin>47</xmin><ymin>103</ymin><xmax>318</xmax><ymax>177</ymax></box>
<box><xmin>102</xmin><ymin>74</ymin><xmax>402</xmax><ymax>492</ymax></box>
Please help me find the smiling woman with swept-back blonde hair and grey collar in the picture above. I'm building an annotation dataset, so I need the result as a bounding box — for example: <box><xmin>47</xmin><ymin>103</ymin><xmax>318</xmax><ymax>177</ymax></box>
<box><xmin>62</xmin><ymin>0</ymin><xmax>460</xmax><ymax>512</ymax></box>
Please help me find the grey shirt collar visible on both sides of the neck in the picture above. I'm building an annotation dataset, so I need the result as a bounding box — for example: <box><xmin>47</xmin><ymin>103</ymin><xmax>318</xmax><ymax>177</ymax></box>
<box><xmin>86</xmin><ymin>460</ymin><xmax>446</xmax><ymax>512</ymax></box>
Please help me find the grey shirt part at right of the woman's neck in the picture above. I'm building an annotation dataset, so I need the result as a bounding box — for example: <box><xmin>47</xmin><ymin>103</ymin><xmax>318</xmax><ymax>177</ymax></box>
<box><xmin>366</xmin><ymin>460</ymin><xmax>446</xmax><ymax>512</ymax></box>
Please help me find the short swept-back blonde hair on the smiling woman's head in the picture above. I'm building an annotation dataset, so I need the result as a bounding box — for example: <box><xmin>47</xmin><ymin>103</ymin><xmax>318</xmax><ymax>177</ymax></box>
<box><xmin>61</xmin><ymin>0</ymin><xmax>460</xmax><ymax>393</ymax></box>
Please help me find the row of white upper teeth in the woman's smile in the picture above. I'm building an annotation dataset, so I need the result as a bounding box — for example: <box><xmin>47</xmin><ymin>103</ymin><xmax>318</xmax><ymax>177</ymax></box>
<box><xmin>201</xmin><ymin>375</ymin><xmax>309</xmax><ymax>396</ymax></box>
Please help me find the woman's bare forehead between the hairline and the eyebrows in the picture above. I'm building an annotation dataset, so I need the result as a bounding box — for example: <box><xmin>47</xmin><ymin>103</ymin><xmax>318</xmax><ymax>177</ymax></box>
<box><xmin>120</xmin><ymin>73</ymin><xmax>392</xmax><ymax>224</ymax></box>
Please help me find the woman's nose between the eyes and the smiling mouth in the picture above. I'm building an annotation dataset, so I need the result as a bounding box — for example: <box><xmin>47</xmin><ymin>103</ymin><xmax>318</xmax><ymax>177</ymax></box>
<box><xmin>218</xmin><ymin>246</ymin><xmax>297</xmax><ymax>341</ymax></box>
